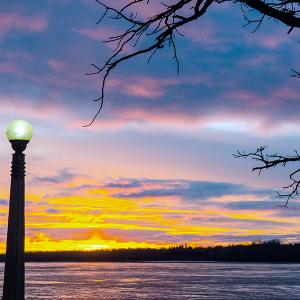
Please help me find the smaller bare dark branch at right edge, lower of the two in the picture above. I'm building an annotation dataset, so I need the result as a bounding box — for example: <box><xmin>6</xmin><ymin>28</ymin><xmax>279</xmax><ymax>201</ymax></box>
<box><xmin>233</xmin><ymin>146</ymin><xmax>300</xmax><ymax>207</ymax></box>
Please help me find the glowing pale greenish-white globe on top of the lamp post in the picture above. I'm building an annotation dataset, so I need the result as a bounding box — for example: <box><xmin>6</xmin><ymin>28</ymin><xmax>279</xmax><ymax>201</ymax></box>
<box><xmin>6</xmin><ymin>120</ymin><xmax>32</xmax><ymax>142</ymax></box>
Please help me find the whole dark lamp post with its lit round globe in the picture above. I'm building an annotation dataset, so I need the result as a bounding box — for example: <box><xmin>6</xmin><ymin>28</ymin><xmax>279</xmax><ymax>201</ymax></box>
<box><xmin>2</xmin><ymin>120</ymin><xmax>32</xmax><ymax>300</ymax></box>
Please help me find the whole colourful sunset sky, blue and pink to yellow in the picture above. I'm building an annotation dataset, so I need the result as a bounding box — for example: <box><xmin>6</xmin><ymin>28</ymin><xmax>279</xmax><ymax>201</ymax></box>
<box><xmin>0</xmin><ymin>0</ymin><xmax>300</xmax><ymax>252</ymax></box>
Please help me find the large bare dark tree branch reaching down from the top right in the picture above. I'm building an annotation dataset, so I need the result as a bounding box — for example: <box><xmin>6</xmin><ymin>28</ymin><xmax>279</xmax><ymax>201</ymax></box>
<box><xmin>84</xmin><ymin>0</ymin><xmax>300</xmax><ymax>127</ymax></box>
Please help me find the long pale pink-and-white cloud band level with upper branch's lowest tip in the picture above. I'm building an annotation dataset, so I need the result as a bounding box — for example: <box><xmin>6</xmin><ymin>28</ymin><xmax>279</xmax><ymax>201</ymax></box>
<box><xmin>71</xmin><ymin>103</ymin><xmax>300</xmax><ymax>135</ymax></box>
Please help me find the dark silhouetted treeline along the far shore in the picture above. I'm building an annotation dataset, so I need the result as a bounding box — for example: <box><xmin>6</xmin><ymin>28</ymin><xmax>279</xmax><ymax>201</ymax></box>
<box><xmin>0</xmin><ymin>240</ymin><xmax>300</xmax><ymax>262</ymax></box>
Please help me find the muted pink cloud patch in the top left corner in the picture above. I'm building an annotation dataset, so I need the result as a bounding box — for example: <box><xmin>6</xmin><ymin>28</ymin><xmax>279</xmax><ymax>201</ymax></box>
<box><xmin>0</xmin><ymin>12</ymin><xmax>47</xmax><ymax>36</ymax></box>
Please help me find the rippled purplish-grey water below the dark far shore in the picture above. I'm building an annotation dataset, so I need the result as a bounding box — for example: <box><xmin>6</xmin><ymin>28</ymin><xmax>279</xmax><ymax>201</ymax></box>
<box><xmin>0</xmin><ymin>262</ymin><xmax>300</xmax><ymax>300</ymax></box>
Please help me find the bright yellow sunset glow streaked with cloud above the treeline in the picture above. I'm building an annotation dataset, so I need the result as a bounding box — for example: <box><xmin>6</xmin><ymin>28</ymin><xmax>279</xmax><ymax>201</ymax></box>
<box><xmin>0</xmin><ymin>182</ymin><xmax>300</xmax><ymax>253</ymax></box>
